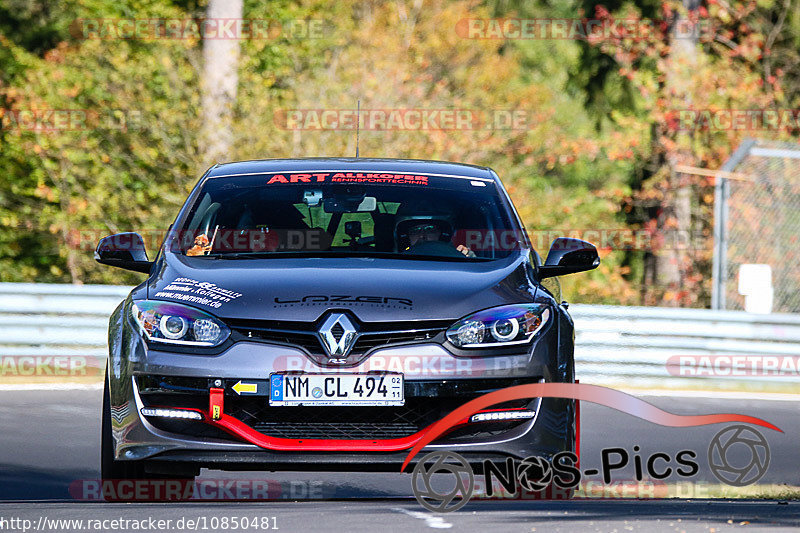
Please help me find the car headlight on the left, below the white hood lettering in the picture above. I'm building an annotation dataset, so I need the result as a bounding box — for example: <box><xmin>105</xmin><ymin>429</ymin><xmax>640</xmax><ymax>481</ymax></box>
<box><xmin>131</xmin><ymin>300</ymin><xmax>231</xmax><ymax>346</ymax></box>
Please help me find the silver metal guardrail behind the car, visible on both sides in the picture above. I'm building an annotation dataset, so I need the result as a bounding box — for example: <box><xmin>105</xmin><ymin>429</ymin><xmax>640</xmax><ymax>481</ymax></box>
<box><xmin>0</xmin><ymin>283</ymin><xmax>800</xmax><ymax>387</ymax></box>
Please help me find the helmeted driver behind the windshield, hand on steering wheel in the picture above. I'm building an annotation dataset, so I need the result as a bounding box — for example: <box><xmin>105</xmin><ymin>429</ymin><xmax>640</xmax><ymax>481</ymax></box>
<box><xmin>395</xmin><ymin>204</ymin><xmax>475</xmax><ymax>257</ymax></box>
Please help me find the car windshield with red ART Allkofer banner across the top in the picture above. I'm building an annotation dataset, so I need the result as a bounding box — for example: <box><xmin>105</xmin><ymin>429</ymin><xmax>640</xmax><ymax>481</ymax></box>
<box><xmin>168</xmin><ymin>172</ymin><xmax>524</xmax><ymax>261</ymax></box>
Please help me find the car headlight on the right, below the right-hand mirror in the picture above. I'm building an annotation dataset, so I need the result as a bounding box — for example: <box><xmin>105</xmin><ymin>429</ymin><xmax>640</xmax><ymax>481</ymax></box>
<box><xmin>447</xmin><ymin>304</ymin><xmax>550</xmax><ymax>348</ymax></box>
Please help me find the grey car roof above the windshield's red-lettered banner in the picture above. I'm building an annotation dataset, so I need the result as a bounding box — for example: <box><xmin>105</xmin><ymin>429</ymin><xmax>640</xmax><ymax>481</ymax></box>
<box><xmin>206</xmin><ymin>157</ymin><xmax>496</xmax><ymax>179</ymax></box>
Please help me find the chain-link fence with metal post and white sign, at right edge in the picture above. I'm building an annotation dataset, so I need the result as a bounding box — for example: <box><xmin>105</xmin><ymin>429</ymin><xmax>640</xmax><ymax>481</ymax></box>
<box><xmin>712</xmin><ymin>140</ymin><xmax>800</xmax><ymax>313</ymax></box>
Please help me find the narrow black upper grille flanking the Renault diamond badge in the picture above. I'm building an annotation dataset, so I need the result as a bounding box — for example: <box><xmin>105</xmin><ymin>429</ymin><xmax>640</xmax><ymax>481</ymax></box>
<box><xmin>226</xmin><ymin>320</ymin><xmax>452</xmax><ymax>365</ymax></box>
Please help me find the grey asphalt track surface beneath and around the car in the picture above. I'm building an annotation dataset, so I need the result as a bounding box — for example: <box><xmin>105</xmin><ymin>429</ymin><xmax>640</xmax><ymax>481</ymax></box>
<box><xmin>0</xmin><ymin>389</ymin><xmax>800</xmax><ymax>532</ymax></box>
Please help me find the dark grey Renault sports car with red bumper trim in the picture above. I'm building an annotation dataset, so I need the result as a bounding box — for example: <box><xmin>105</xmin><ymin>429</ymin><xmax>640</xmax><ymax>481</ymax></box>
<box><xmin>96</xmin><ymin>159</ymin><xmax>599</xmax><ymax>479</ymax></box>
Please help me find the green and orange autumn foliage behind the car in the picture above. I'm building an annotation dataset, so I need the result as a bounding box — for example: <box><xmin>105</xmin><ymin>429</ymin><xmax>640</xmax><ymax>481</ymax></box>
<box><xmin>0</xmin><ymin>0</ymin><xmax>800</xmax><ymax>307</ymax></box>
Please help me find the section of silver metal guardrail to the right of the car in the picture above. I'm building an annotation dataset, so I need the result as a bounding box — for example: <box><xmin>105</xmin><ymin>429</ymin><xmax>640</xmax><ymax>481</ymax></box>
<box><xmin>570</xmin><ymin>305</ymin><xmax>800</xmax><ymax>386</ymax></box>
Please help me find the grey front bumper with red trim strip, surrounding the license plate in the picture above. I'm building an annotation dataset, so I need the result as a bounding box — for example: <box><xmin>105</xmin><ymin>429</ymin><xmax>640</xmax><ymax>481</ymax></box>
<box><xmin>109</xmin><ymin>334</ymin><xmax>574</xmax><ymax>471</ymax></box>
